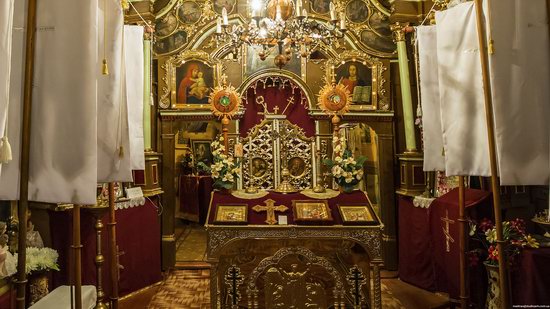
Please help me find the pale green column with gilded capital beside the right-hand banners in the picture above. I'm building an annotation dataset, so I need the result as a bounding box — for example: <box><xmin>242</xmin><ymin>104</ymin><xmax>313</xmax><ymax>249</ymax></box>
<box><xmin>391</xmin><ymin>23</ymin><xmax>417</xmax><ymax>152</ymax></box>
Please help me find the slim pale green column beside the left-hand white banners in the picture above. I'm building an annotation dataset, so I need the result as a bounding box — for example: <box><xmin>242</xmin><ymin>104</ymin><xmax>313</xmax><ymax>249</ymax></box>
<box><xmin>143</xmin><ymin>34</ymin><xmax>153</xmax><ymax>152</ymax></box>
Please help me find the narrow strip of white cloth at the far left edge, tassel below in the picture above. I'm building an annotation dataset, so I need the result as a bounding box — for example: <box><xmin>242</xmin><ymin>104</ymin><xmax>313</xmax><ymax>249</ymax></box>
<box><xmin>0</xmin><ymin>0</ymin><xmax>14</xmax><ymax>173</ymax></box>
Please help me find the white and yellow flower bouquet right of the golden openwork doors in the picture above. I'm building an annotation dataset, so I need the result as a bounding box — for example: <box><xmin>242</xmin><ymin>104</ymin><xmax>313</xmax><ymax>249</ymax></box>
<box><xmin>323</xmin><ymin>134</ymin><xmax>367</xmax><ymax>192</ymax></box>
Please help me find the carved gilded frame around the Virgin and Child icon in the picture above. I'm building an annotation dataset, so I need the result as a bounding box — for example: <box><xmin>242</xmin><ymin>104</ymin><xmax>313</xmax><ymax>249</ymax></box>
<box><xmin>159</xmin><ymin>50</ymin><xmax>223</xmax><ymax>111</ymax></box>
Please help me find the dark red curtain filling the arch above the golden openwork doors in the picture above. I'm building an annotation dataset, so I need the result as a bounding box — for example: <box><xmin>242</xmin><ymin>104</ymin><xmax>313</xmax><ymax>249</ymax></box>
<box><xmin>240</xmin><ymin>77</ymin><xmax>315</xmax><ymax>137</ymax></box>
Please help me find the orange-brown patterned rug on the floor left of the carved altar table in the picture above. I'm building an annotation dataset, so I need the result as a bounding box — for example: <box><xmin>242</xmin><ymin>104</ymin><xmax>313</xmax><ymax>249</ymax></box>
<box><xmin>147</xmin><ymin>269</ymin><xmax>210</xmax><ymax>309</ymax></box>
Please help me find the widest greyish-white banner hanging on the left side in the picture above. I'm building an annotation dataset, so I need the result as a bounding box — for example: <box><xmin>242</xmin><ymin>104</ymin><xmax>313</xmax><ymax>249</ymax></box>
<box><xmin>25</xmin><ymin>0</ymin><xmax>98</xmax><ymax>204</ymax></box>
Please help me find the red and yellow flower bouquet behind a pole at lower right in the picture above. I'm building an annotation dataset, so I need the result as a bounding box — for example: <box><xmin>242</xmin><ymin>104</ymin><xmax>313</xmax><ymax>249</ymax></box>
<box><xmin>469</xmin><ymin>218</ymin><xmax>539</xmax><ymax>266</ymax></box>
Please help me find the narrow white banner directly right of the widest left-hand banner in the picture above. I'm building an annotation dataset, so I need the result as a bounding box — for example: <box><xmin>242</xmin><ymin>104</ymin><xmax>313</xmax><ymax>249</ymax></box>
<box><xmin>94</xmin><ymin>0</ymin><xmax>132</xmax><ymax>182</ymax></box>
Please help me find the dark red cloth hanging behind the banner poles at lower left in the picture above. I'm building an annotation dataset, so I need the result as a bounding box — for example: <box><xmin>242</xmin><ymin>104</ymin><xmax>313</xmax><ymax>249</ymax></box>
<box><xmin>50</xmin><ymin>199</ymin><xmax>162</xmax><ymax>297</ymax></box>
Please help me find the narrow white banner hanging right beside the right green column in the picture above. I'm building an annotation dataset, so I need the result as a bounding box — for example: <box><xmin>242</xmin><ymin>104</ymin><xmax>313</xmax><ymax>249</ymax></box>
<box><xmin>416</xmin><ymin>26</ymin><xmax>445</xmax><ymax>171</ymax></box>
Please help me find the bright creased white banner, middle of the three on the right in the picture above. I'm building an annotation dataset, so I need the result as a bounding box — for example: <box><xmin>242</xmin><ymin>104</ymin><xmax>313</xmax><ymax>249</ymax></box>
<box><xmin>435</xmin><ymin>2</ymin><xmax>490</xmax><ymax>176</ymax></box>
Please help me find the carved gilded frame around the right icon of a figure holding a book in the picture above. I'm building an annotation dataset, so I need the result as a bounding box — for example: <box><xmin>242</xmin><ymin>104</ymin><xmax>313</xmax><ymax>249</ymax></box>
<box><xmin>325</xmin><ymin>50</ymin><xmax>390</xmax><ymax>112</ymax></box>
